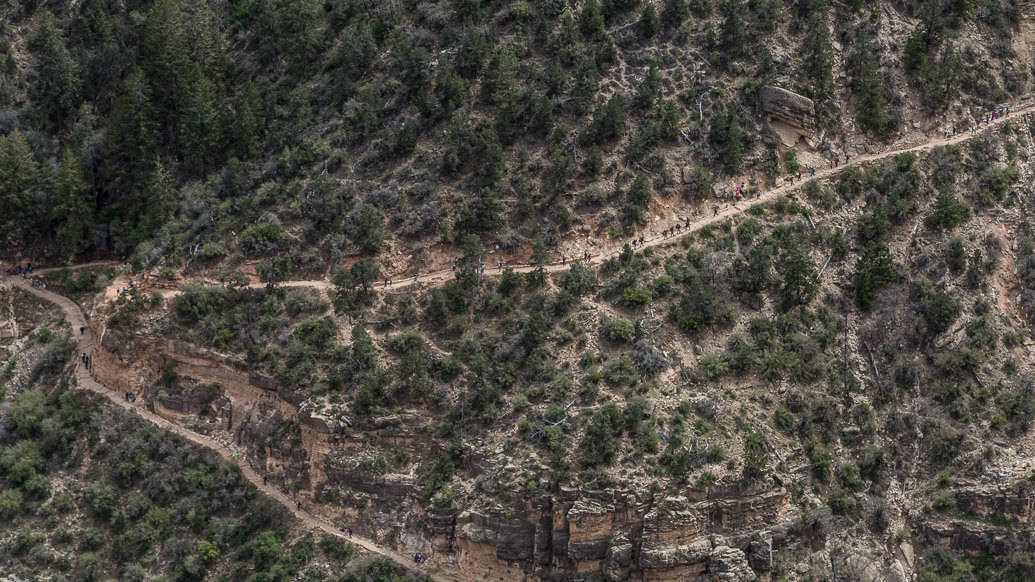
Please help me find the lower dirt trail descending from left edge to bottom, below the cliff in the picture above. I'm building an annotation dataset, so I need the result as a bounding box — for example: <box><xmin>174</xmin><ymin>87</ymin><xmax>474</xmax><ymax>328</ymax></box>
<box><xmin>6</xmin><ymin>277</ymin><xmax>459</xmax><ymax>581</ymax></box>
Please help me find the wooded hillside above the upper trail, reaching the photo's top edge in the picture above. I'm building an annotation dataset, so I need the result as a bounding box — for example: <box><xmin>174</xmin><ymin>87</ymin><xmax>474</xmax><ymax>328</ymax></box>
<box><xmin>0</xmin><ymin>0</ymin><xmax>1032</xmax><ymax>267</ymax></box>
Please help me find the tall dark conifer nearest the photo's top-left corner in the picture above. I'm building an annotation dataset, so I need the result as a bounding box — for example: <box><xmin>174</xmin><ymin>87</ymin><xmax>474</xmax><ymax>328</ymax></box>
<box><xmin>29</xmin><ymin>10</ymin><xmax>80</xmax><ymax>127</ymax></box>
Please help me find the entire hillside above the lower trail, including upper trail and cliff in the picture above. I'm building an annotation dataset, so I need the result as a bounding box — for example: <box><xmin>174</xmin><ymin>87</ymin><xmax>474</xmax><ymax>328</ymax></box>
<box><xmin>0</xmin><ymin>0</ymin><xmax>1035</xmax><ymax>581</ymax></box>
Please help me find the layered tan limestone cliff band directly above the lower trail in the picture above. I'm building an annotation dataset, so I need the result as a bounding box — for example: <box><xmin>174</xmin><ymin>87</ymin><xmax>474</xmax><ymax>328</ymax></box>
<box><xmin>94</xmin><ymin>333</ymin><xmax>789</xmax><ymax>582</ymax></box>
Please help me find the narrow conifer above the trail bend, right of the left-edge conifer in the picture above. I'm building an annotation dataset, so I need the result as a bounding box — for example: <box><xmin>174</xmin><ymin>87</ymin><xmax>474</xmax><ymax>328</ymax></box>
<box><xmin>54</xmin><ymin>148</ymin><xmax>93</xmax><ymax>258</ymax></box>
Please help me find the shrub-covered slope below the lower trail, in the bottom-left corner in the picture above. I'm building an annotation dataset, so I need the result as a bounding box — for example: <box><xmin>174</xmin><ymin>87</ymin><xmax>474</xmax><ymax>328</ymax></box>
<box><xmin>0</xmin><ymin>288</ymin><xmax>426</xmax><ymax>582</ymax></box>
